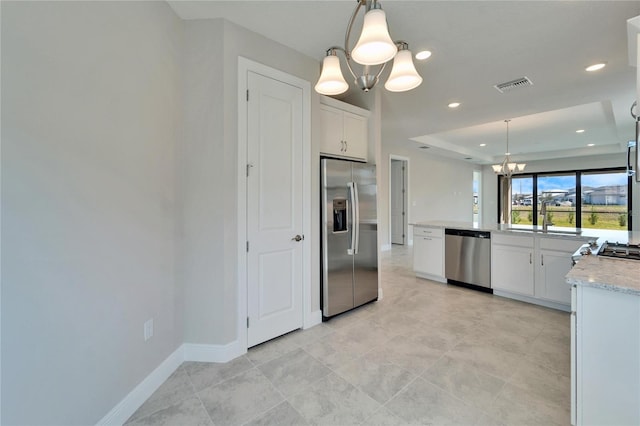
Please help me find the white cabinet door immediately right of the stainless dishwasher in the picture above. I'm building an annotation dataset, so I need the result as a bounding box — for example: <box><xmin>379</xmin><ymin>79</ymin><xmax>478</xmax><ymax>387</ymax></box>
<box><xmin>491</xmin><ymin>244</ymin><xmax>534</xmax><ymax>296</ymax></box>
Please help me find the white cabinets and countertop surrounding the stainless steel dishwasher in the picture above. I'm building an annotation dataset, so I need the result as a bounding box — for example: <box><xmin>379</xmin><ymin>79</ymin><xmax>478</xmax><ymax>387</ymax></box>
<box><xmin>413</xmin><ymin>221</ymin><xmax>599</xmax><ymax>312</ymax></box>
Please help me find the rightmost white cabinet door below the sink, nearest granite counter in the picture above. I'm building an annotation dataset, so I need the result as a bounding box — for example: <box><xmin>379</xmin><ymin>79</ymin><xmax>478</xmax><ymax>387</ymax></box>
<box><xmin>536</xmin><ymin>250</ymin><xmax>571</xmax><ymax>305</ymax></box>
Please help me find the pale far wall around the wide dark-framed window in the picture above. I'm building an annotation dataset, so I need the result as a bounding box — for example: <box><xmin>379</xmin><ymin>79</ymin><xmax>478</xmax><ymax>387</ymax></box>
<box><xmin>482</xmin><ymin>152</ymin><xmax>640</xmax><ymax>231</ymax></box>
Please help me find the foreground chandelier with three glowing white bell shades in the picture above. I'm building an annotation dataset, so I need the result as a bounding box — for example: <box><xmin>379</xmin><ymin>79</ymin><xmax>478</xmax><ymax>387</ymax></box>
<box><xmin>315</xmin><ymin>0</ymin><xmax>422</xmax><ymax>95</ymax></box>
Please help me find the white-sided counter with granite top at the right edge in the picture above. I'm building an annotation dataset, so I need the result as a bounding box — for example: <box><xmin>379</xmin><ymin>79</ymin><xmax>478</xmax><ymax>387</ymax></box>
<box><xmin>566</xmin><ymin>253</ymin><xmax>640</xmax><ymax>425</ymax></box>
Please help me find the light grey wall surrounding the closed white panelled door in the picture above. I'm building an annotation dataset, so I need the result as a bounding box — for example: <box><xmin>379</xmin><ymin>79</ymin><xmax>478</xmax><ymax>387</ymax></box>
<box><xmin>181</xmin><ymin>19</ymin><xmax>320</xmax><ymax>345</ymax></box>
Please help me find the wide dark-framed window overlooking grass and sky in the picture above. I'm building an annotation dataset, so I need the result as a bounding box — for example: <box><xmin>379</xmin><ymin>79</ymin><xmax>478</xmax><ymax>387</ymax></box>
<box><xmin>498</xmin><ymin>168</ymin><xmax>631</xmax><ymax>230</ymax></box>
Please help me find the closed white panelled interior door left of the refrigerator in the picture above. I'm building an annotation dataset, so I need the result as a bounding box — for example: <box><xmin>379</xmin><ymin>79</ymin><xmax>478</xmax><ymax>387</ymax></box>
<box><xmin>247</xmin><ymin>72</ymin><xmax>303</xmax><ymax>347</ymax></box>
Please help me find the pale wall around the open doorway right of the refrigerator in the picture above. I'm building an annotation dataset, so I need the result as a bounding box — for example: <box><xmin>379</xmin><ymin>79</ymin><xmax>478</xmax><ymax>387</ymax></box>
<box><xmin>378</xmin><ymin>138</ymin><xmax>477</xmax><ymax>246</ymax></box>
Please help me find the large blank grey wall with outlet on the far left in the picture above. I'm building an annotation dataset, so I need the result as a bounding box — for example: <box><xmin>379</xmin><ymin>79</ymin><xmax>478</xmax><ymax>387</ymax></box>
<box><xmin>1</xmin><ymin>2</ymin><xmax>183</xmax><ymax>425</ymax></box>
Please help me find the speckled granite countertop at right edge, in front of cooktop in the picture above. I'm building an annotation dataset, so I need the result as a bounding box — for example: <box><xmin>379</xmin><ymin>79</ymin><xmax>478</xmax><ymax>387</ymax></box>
<box><xmin>567</xmin><ymin>256</ymin><xmax>640</xmax><ymax>296</ymax></box>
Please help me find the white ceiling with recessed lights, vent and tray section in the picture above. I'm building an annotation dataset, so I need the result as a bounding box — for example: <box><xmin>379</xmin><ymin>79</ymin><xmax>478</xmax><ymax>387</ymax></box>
<box><xmin>169</xmin><ymin>0</ymin><xmax>640</xmax><ymax>164</ymax></box>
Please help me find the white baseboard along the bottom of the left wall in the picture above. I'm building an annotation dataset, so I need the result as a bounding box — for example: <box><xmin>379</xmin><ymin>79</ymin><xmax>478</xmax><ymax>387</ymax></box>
<box><xmin>97</xmin><ymin>345</ymin><xmax>184</xmax><ymax>425</ymax></box>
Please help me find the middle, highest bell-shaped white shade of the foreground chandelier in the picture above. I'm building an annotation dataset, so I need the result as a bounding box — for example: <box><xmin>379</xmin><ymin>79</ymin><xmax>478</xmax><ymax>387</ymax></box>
<box><xmin>351</xmin><ymin>9</ymin><xmax>398</xmax><ymax>65</ymax></box>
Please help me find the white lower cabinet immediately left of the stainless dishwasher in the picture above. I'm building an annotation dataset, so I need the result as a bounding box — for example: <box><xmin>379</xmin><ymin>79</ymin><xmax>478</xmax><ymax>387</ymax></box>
<box><xmin>413</xmin><ymin>226</ymin><xmax>445</xmax><ymax>281</ymax></box>
